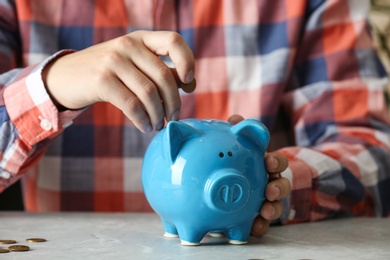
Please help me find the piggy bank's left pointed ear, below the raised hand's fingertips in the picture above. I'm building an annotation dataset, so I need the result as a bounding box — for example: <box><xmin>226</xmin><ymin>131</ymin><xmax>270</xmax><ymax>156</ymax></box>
<box><xmin>164</xmin><ymin>121</ymin><xmax>202</xmax><ymax>164</ymax></box>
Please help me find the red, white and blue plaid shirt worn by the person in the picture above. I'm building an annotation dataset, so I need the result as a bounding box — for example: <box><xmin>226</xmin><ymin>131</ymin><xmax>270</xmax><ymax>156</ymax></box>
<box><xmin>0</xmin><ymin>0</ymin><xmax>390</xmax><ymax>223</ymax></box>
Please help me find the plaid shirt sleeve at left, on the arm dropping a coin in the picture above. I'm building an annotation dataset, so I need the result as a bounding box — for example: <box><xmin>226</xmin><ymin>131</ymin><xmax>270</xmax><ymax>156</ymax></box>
<box><xmin>0</xmin><ymin>1</ymin><xmax>81</xmax><ymax>192</ymax></box>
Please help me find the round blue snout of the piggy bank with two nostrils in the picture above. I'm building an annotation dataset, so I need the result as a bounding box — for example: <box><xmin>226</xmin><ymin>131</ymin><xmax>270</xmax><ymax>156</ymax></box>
<box><xmin>204</xmin><ymin>169</ymin><xmax>251</xmax><ymax>212</ymax></box>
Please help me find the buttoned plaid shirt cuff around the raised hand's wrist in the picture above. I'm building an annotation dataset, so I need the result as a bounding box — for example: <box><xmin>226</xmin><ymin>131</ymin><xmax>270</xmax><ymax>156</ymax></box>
<box><xmin>4</xmin><ymin>50</ymin><xmax>83</xmax><ymax>146</ymax></box>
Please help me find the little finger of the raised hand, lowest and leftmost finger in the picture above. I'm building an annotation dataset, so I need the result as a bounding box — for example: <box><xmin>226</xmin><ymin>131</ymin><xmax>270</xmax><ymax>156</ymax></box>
<box><xmin>102</xmin><ymin>77</ymin><xmax>152</xmax><ymax>133</ymax></box>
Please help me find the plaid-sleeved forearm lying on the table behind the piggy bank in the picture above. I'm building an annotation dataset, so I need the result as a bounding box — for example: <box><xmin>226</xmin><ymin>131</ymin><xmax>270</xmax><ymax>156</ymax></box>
<box><xmin>281</xmin><ymin>138</ymin><xmax>390</xmax><ymax>223</ymax></box>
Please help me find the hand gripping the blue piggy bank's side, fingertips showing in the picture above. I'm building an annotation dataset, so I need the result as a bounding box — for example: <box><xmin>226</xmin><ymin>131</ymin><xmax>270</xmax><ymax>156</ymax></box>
<box><xmin>228</xmin><ymin>115</ymin><xmax>291</xmax><ymax>236</ymax></box>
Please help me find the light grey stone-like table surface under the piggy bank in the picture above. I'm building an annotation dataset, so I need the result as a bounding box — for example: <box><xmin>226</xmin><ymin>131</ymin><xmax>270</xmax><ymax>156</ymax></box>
<box><xmin>0</xmin><ymin>212</ymin><xmax>390</xmax><ymax>260</ymax></box>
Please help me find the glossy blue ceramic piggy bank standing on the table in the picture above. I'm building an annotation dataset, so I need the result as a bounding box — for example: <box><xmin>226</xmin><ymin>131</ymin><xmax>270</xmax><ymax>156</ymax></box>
<box><xmin>142</xmin><ymin>119</ymin><xmax>270</xmax><ymax>245</ymax></box>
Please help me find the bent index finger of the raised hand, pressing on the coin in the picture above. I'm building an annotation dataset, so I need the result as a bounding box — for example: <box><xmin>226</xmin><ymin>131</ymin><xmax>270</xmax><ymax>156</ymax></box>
<box><xmin>140</xmin><ymin>31</ymin><xmax>195</xmax><ymax>83</ymax></box>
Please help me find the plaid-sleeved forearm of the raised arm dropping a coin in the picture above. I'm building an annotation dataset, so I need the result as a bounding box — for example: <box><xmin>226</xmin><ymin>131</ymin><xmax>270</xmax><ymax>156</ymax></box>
<box><xmin>0</xmin><ymin>56</ymin><xmax>81</xmax><ymax>191</ymax></box>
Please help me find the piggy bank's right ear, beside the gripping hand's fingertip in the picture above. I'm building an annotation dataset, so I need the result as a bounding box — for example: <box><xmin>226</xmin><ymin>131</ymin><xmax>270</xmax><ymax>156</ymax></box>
<box><xmin>230</xmin><ymin>119</ymin><xmax>270</xmax><ymax>152</ymax></box>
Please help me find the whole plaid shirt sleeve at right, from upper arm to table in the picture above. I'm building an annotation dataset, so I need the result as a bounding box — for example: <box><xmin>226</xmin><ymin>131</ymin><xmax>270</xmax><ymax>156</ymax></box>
<box><xmin>280</xmin><ymin>1</ymin><xmax>390</xmax><ymax>224</ymax></box>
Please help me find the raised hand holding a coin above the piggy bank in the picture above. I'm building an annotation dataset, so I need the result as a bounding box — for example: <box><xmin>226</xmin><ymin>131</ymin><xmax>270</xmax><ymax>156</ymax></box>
<box><xmin>43</xmin><ymin>31</ymin><xmax>195</xmax><ymax>132</ymax></box>
